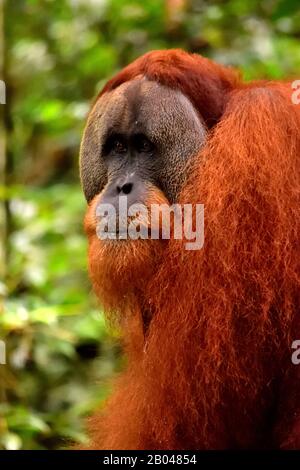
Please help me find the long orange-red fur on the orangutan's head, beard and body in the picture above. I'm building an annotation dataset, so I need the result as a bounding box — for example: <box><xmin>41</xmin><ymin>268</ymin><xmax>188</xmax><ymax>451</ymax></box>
<box><xmin>86</xmin><ymin>51</ymin><xmax>300</xmax><ymax>449</ymax></box>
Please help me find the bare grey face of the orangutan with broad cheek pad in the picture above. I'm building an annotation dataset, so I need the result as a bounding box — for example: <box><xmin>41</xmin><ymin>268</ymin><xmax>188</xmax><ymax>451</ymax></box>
<box><xmin>80</xmin><ymin>78</ymin><xmax>206</xmax><ymax>214</ymax></box>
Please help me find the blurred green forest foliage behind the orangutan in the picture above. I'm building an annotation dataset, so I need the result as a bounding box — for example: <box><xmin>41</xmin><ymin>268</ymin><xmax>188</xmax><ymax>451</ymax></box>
<box><xmin>0</xmin><ymin>0</ymin><xmax>300</xmax><ymax>449</ymax></box>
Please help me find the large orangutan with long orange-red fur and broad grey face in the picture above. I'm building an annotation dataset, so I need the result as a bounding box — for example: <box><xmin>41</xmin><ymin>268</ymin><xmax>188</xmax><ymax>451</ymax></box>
<box><xmin>81</xmin><ymin>50</ymin><xmax>300</xmax><ymax>449</ymax></box>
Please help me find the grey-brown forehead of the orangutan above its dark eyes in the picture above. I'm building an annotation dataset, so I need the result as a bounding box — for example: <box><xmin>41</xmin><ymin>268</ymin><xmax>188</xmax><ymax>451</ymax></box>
<box><xmin>91</xmin><ymin>77</ymin><xmax>202</xmax><ymax>141</ymax></box>
